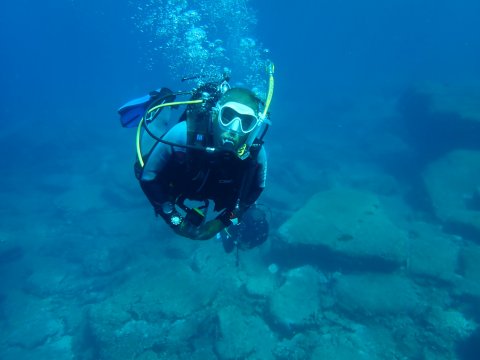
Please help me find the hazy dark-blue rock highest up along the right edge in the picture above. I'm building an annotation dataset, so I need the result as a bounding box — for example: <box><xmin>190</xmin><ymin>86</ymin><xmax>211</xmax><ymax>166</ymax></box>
<box><xmin>398</xmin><ymin>83</ymin><xmax>480</xmax><ymax>166</ymax></box>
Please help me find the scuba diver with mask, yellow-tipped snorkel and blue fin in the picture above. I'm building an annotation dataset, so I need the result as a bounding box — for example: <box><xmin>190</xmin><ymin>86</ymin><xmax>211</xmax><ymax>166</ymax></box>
<box><xmin>119</xmin><ymin>64</ymin><xmax>273</xmax><ymax>254</ymax></box>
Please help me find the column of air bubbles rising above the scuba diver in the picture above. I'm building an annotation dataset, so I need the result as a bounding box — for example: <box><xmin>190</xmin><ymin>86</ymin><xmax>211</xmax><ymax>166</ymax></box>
<box><xmin>131</xmin><ymin>0</ymin><xmax>268</xmax><ymax>97</ymax></box>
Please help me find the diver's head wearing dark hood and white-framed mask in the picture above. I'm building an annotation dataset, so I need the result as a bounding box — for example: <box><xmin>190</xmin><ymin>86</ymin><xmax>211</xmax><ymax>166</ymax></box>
<box><xmin>213</xmin><ymin>88</ymin><xmax>263</xmax><ymax>159</ymax></box>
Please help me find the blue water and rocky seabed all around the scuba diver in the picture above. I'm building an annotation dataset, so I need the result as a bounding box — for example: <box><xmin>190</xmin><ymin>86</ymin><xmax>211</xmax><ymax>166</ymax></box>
<box><xmin>0</xmin><ymin>0</ymin><xmax>480</xmax><ymax>360</ymax></box>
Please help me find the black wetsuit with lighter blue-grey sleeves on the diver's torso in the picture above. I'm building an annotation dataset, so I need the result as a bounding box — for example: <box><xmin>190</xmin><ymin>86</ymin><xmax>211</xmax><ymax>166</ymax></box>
<box><xmin>139</xmin><ymin>121</ymin><xmax>267</xmax><ymax>221</ymax></box>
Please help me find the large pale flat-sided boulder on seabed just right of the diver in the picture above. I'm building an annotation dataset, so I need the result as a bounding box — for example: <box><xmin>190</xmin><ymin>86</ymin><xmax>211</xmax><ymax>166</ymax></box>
<box><xmin>280</xmin><ymin>188</ymin><xmax>407</xmax><ymax>267</ymax></box>
